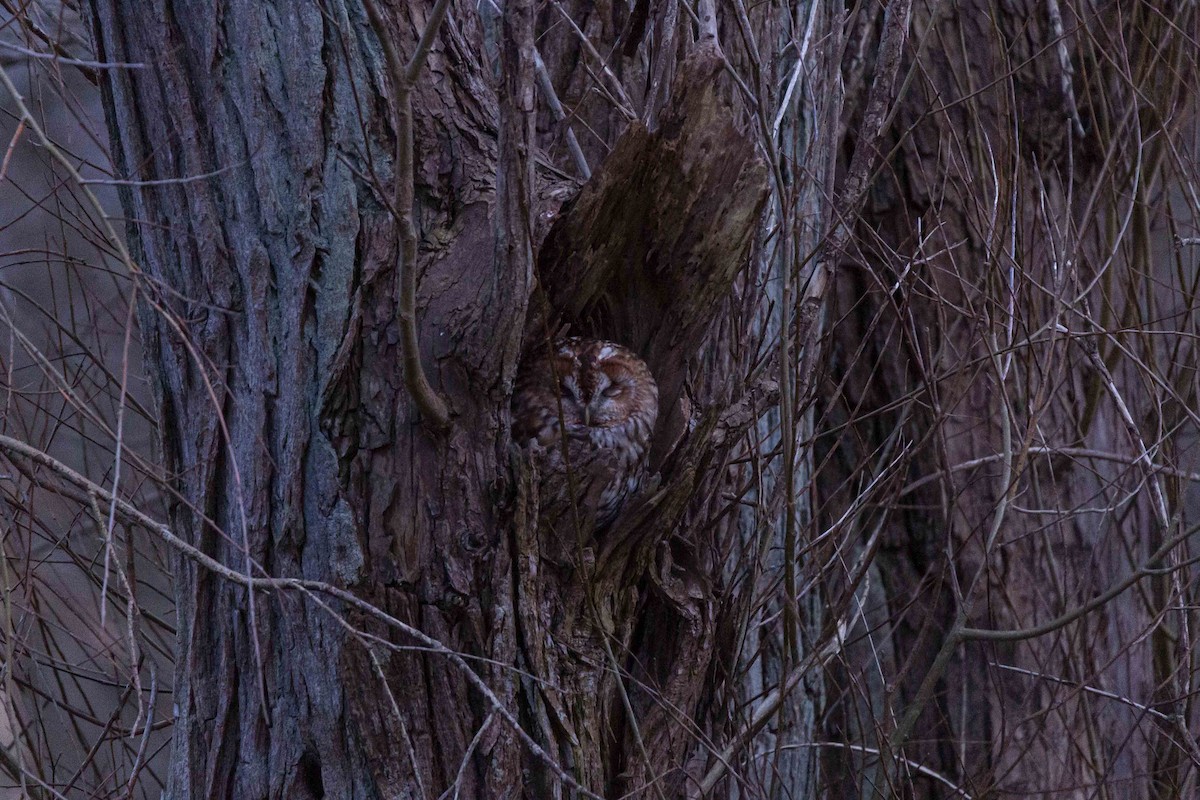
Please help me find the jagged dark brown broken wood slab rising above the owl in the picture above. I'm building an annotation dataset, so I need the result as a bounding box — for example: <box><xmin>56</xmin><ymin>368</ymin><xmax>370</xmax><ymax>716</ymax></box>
<box><xmin>527</xmin><ymin>46</ymin><xmax>768</xmax><ymax>458</ymax></box>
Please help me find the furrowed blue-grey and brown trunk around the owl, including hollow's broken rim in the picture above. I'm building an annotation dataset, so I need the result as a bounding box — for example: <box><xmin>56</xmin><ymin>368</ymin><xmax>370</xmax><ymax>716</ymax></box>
<box><xmin>84</xmin><ymin>0</ymin><xmax>774</xmax><ymax>798</ymax></box>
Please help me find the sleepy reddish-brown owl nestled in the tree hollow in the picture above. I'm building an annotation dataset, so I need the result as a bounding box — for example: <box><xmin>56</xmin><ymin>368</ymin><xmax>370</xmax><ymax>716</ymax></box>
<box><xmin>512</xmin><ymin>337</ymin><xmax>659</xmax><ymax>528</ymax></box>
